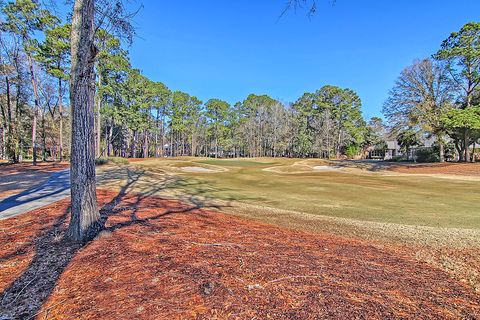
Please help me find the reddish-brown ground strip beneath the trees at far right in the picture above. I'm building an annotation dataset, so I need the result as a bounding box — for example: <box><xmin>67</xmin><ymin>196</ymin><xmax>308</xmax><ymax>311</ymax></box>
<box><xmin>389</xmin><ymin>163</ymin><xmax>480</xmax><ymax>177</ymax></box>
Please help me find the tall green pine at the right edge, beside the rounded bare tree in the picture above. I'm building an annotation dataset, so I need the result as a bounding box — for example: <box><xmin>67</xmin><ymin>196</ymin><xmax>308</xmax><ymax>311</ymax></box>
<box><xmin>434</xmin><ymin>22</ymin><xmax>480</xmax><ymax>161</ymax></box>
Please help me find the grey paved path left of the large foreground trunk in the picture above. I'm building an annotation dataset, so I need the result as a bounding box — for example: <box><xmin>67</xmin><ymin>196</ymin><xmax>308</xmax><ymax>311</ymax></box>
<box><xmin>0</xmin><ymin>169</ymin><xmax>70</xmax><ymax>220</ymax></box>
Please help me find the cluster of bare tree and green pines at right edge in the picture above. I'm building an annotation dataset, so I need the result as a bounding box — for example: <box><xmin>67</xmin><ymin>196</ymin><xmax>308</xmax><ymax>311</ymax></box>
<box><xmin>383</xmin><ymin>22</ymin><xmax>480</xmax><ymax>162</ymax></box>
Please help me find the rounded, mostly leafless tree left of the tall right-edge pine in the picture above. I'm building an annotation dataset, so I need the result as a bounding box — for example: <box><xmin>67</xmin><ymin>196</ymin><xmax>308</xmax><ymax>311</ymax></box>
<box><xmin>383</xmin><ymin>59</ymin><xmax>453</xmax><ymax>162</ymax></box>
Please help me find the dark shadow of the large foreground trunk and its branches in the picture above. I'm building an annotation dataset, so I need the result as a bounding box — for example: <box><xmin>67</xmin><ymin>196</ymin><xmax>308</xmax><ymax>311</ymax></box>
<box><xmin>0</xmin><ymin>168</ymin><xmax>242</xmax><ymax>320</ymax></box>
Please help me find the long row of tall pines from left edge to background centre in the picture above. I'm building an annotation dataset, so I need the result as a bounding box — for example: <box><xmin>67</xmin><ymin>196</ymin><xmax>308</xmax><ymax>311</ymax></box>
<box><xmin>0</xmin><ymin>0</ymin><xmax>382</xmax><ymax>163</ymax></box>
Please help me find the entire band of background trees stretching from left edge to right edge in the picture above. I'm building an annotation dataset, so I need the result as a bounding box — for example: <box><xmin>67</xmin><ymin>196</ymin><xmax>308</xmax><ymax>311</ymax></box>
<box><xmin>0</xmin><ymin>0</ymin><xmax>480</xmax><ymax>162</ymax></box>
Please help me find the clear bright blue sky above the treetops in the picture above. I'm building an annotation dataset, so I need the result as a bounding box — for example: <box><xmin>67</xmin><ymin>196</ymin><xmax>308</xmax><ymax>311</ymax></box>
<box><xmin>63</xmin><ymin>0</ymin><xmax>480</xmax><ymax>117</ymax></box>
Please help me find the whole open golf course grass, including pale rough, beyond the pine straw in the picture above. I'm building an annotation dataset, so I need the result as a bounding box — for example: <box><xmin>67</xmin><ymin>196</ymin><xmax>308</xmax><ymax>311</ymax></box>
<box><xmin>94</xmin><ymin>158</ymin><xmax>480</xmax><ymax>290</ymax></box>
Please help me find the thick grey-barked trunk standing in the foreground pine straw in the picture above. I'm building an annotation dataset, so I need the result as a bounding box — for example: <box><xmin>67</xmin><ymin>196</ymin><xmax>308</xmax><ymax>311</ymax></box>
<box><xmin>66</xmin><ymin>0</ymin><xmax>103</xmax><ymax>242</ymax></box>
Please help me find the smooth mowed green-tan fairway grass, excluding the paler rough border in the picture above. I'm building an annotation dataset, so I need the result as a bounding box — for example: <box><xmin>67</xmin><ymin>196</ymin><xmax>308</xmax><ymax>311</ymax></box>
<box><xmin>124</xmin><ymin>158</ymin><xmax>480</xmax><ymax>229</ymax></box>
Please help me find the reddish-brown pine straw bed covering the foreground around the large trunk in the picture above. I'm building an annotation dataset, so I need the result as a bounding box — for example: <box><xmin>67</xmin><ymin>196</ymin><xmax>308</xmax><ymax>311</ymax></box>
<box><xmin>0</xmin><ymin>191</ymin><xmax>480</xmax><ymax>319</ymax></box>
